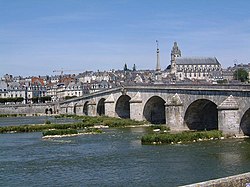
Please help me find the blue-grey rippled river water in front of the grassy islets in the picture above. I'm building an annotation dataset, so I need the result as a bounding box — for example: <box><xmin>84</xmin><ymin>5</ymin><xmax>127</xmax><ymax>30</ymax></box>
<box><xmin>0</xmin><ymin>118</ymin><xmax>250</xmax><ymax>186</ymax></box>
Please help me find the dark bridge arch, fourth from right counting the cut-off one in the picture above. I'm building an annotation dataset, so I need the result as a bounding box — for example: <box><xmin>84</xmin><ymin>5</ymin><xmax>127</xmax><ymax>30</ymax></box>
<box><xmin>115</xmin><ymin>95</ymin><xmax>131</xmax><ymax>118</ymax></box>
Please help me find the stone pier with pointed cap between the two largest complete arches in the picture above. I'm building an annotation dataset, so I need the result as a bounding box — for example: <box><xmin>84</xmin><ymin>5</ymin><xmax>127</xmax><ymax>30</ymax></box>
<box><xmin>165</xmin><ymin>94</ymin><xmax>188</xmax><ymax>131</ymax></box>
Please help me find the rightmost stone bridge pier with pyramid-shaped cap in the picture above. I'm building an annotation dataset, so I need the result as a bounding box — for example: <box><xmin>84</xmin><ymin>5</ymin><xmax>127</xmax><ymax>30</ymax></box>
<box><xmin>217</xmin><ymin>95</ymin><xmax>240</xmax><ymax>134</ymax></box>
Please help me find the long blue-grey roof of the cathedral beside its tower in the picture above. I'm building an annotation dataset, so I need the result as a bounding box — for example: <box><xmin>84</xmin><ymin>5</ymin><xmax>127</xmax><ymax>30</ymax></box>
<box><xmin>176</xmin><ymin>57</ymin><xmax>220</xmax><ymax>65</ymax></box>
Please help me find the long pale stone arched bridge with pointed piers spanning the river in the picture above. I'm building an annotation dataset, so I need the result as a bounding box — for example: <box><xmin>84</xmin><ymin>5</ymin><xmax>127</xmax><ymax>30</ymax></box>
<box><xmin>60</xmin><ymin>85</ymin><xmax>250</xmax><ymax>135</ymax></box>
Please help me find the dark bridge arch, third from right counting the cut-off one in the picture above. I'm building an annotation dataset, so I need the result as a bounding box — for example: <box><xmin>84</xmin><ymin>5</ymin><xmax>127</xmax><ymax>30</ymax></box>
<box><xmin>143</xmin><ymin>96</ymin><xmax>166</xmax><ymax>124</ymax></box>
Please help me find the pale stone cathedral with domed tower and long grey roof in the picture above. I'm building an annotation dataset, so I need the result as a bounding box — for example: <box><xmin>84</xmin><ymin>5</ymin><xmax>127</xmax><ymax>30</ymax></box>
<box><xmin>170</xmin><ymin>42</ymin><xmax>222</xmax><ymax>81</ymax></box>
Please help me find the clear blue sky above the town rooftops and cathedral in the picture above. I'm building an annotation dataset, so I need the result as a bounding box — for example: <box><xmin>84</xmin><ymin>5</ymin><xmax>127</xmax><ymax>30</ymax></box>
<box><xmin>0</xmin><ymin>0</ymin><xmax>250</xmax><ymax>77</ymax></box>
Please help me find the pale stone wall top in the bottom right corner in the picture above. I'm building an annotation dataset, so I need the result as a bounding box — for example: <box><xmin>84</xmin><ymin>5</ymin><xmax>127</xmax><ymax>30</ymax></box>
<box><xmin>182</xmin><ymin>172</ymin><xmax>250</xmax><ymax>187</ymax></box>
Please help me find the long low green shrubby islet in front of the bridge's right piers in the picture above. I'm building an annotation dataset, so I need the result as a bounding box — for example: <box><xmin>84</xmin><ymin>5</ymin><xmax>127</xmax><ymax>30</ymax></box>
<box><xmin>141</xmin><ymin>130</ymin><xmax>223</xmax><ymax>144</ymax></box>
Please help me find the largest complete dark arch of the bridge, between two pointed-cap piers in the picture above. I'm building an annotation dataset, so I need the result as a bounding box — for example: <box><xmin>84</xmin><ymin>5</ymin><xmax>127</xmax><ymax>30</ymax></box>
<box><xmin>184</xmin><ymin>99</ymin><xmax>218</xmax><ymax>130</ymax></box>
